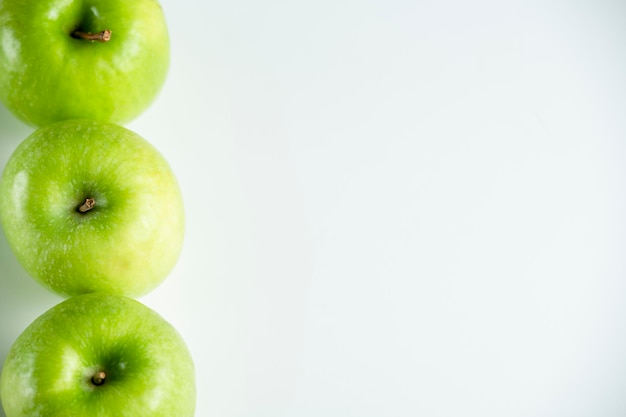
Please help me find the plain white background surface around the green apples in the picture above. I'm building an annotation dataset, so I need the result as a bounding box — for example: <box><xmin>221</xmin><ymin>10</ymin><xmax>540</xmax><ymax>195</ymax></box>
<box><xmin>0</xmin><ymin>0</ymin><xmax>626</xmax><ymax>417</ymax></box>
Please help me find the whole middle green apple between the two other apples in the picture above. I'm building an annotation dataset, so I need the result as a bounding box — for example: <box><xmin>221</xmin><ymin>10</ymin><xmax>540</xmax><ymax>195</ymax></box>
<box><xmin>0</xmin><ymin>120</ymin><xmax>184</xmax><ymax>297</ymax></box>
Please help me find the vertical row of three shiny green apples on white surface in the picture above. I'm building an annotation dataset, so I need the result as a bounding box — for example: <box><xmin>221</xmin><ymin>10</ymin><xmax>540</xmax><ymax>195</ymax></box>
<box><xmin>0</xmin><ymin>0</ymin><xmax>195</xmax><ymax>417</ymax></box>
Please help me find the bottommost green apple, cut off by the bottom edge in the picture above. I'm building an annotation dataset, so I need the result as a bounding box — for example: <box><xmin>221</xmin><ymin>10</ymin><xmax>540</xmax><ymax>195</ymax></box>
<box><xmin>0</xmin><ymin>293</ymin><xmax>195</xmax><ymax>417</ymax></box>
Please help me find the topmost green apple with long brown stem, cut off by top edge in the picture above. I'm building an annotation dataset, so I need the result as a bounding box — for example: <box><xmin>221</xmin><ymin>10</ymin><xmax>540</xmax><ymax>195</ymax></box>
<box><xmin>0</xmin><ymin>0</ymin><xmax>169</xmax><ymax>126</ymax></box>
